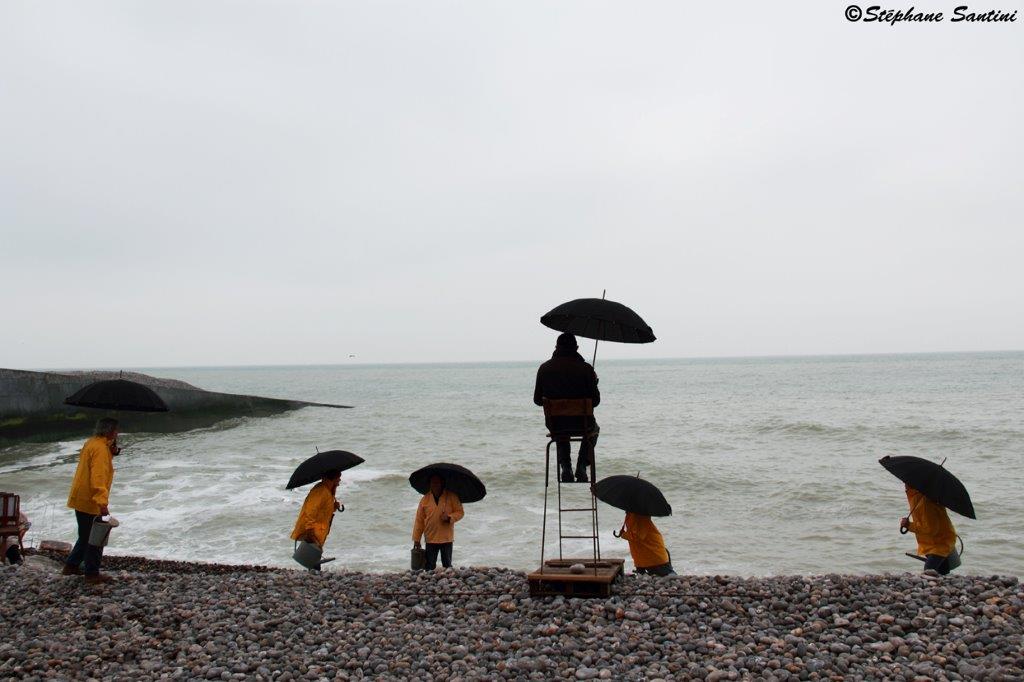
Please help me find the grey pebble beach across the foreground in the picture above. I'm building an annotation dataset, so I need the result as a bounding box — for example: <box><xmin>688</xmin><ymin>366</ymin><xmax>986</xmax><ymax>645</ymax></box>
<box><xmin>0</xmin><ymin>557</ymin><xmax>1024</xmax><ymax>681</ymax></box>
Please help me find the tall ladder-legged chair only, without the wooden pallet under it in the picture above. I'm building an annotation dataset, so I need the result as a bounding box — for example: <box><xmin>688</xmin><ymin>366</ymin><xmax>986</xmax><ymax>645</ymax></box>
<box><xmin>541</xmin><ymin>398</ymin><xmax>601</xmax><ymax>574</ymax></box>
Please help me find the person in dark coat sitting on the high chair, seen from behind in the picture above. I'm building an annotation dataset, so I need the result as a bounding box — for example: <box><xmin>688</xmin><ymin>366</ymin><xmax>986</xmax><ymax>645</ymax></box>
<box><xmin>534</xmin><ymin>333</ymin><xmax>601</xmax><ymax>483</ymax></box>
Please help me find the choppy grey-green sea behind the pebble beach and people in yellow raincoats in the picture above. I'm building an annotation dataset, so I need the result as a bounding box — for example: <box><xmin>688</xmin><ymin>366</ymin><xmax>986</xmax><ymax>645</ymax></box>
<box><xmin>0</xmin><ymin>352</ymin><xmax>1024</xmax><ymax>576</ymax></box>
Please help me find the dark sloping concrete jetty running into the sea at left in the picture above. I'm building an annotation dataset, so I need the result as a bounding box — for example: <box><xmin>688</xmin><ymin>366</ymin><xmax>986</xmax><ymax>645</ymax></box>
<box><xmin>0</xmin><ymin>369</ymin><xmax>351</xmax><ymax>445</ymax></box>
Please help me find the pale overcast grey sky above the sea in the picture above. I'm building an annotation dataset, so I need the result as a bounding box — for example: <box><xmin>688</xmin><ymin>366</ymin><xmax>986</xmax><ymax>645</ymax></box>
<box><xmin>0</xmin><ymin>0</ymin><xmax>1024</xmax><ymax>369</ymax></box>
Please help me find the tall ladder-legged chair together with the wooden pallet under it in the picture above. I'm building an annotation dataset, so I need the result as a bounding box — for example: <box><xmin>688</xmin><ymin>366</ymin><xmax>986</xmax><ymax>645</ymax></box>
<box><xmin>527</xmin><ymin>398</ymin><xmax>625</xmax><ymax>597</ymax></box>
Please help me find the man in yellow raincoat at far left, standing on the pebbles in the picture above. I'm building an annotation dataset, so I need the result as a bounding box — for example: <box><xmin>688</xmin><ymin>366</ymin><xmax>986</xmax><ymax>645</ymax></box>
<box><xmin>62</xmin><ymin>417</ymin><xmax>120</xmax><ymax>583</ymax></box>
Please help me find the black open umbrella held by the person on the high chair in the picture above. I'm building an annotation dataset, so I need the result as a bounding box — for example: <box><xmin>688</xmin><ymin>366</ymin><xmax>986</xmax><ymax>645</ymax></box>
<box><xmin>541</xmin><ymin>297</ymin><xmax>655</xmax><ymax>363</ymax></box>
